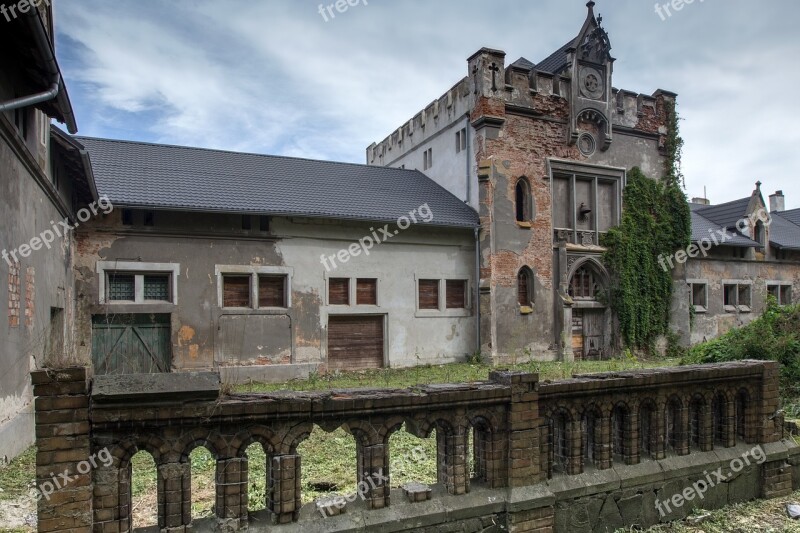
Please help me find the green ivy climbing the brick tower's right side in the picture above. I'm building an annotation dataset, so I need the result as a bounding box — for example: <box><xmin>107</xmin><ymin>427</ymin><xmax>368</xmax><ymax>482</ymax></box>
<box><xmin>603</xmin><ymin>100</ymin><xmax>691</xmax><ymax>350</ymax></box>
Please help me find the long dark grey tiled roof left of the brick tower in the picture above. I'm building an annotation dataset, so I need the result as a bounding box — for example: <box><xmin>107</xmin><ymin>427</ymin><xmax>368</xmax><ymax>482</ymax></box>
<box><xmin>76</xmin><ymin>137</ymin><xmax>479</xmax><ymax>227</ymax></box>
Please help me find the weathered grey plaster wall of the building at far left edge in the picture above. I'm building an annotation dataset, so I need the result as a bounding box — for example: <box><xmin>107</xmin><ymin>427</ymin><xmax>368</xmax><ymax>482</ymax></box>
<box><xmin>0</xmin><ymin>114</ymin><xmax>73</xmax><ymax>458</ymax></box>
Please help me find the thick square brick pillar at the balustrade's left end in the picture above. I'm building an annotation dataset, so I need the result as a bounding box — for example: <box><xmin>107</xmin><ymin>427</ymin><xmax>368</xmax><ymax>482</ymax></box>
<box><xmin>31</xmin><ymin>368</ymin><xmax>97</xmax><ymax>533</ymax></box>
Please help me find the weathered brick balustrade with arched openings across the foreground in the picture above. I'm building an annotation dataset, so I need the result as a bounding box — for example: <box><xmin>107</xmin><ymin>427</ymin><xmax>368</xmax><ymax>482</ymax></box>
<box><xmin>32</xmin><ymin>361</ymin><xmax>796</xmax><ymax>533</ymax></box>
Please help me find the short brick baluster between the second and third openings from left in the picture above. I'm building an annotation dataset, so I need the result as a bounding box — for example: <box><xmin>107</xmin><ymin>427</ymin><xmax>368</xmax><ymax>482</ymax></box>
<box><xmin>215</xmin><ymin>457</ymin><xmax>248</xmax><ymax>531</ymax></box>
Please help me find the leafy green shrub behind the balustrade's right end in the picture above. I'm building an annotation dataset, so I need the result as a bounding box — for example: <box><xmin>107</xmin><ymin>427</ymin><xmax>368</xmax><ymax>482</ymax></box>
<box><xmin>681</xmin><ymin>299</ymin><xmax>800</xmax><ymax>395</ymax></box>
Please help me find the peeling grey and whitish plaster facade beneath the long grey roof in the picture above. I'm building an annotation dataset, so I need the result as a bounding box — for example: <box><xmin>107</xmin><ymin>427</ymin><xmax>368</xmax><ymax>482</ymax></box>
<box><xmin>77</xmin><ymin>212</ymin><xmax>475</xmax><ymax>370</ymax></box>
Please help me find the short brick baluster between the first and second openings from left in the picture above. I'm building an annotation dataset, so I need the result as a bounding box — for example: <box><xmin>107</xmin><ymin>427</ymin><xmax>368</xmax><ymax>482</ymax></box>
<box><xmin>157</xmin><ymin>461</ymin><xmax>192</xmax><ymax>533</ymax></box>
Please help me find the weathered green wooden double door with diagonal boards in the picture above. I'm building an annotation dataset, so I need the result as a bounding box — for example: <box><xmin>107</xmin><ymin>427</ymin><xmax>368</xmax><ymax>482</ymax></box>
<box><xmin>92</xmin><ymin>314</ymin><xmax>172</xmax><ymax>374</ymax></box>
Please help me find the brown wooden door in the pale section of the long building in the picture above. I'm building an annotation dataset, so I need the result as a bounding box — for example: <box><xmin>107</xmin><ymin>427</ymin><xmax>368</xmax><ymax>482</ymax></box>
<box><xmin>328</xmin><ymin>316</ymin><xmax>383</xmax><ymax>370</ymax></box>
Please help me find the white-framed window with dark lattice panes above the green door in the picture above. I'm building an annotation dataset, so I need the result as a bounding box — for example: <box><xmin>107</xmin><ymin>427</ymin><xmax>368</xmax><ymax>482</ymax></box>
<box><xmin>97</xmin><ymin>261</ymin><xmax>180</xmax><ymax>304</ymax></box>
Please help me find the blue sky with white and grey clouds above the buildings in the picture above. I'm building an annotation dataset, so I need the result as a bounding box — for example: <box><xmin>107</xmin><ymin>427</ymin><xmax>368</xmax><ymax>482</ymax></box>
<box><xmin>55</xmin><ymin>0</ymin><xmax>800</xmax><ymax>207</ymax></box>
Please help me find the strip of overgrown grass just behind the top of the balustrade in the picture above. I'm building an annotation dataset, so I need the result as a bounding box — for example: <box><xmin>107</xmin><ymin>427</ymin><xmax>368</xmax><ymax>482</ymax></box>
<box><xmin>233</xmin><ymin>357</ymin><xmax>679</xmax><ymax>393</ymax></box>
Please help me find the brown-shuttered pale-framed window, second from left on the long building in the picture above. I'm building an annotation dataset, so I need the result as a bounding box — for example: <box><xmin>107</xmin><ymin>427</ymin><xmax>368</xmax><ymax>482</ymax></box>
<box><xmin>215</xmin><ymin>265</ymin><xmax>291</xmax><ymax>310</ymax></box>
